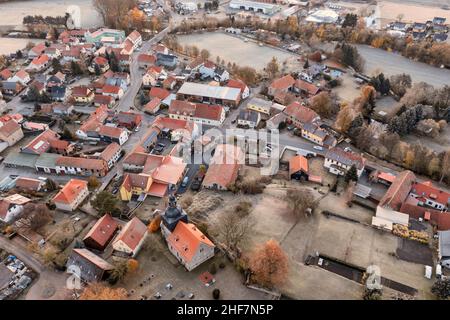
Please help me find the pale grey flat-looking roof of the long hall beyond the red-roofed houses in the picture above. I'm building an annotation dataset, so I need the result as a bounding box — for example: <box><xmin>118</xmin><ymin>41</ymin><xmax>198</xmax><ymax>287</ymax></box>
<box><xmin>178</xmin><ymin>82</ymin><xmax>241</xmax><ymax>101</ymax></box>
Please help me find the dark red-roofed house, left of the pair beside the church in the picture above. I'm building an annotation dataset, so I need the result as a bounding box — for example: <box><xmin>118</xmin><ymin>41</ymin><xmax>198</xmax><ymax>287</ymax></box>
<box><xmin>83</xmin><ymin>214</ymin><xmax>119</xmax><ymax>251</ymax></box>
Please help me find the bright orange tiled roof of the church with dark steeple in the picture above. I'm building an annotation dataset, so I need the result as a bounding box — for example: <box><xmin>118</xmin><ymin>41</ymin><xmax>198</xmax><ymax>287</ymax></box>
<box><xmin>167</xmin><ymin>221</ymin><xmax>214</xmax><ymax>262</ymax></box>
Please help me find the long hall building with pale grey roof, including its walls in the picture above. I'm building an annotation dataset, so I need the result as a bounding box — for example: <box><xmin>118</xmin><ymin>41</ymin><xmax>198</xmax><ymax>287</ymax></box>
<box><xmin>177</xmin><ymin>82</ymin><xmax>241</xmax><ymax>107</ymax></box>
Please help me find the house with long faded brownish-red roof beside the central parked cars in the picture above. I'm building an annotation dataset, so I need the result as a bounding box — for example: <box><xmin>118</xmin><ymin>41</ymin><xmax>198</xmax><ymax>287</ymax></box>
<box><xmin>202</xmin><ymin>144</ymin><xmax>245</xmax><ymax>190</ymax></box>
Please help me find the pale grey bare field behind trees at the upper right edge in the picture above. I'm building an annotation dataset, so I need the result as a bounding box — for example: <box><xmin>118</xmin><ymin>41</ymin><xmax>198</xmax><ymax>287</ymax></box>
<box><xmin>357</xmin><ymin>45</ymin><xmax>450</xmax><ymax>87</ymax></box>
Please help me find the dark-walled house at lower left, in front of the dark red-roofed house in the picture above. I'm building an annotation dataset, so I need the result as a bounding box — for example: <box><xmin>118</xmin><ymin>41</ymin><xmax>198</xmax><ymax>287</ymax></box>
<box><xmin>66</xmin><ymin>249</ymin><xmax>114</xmax><ymax>283</ymax></box>
